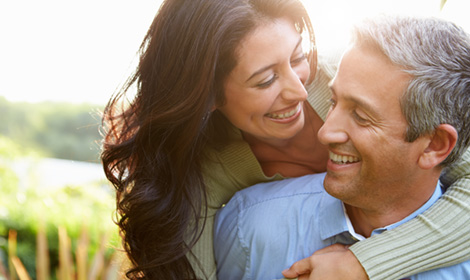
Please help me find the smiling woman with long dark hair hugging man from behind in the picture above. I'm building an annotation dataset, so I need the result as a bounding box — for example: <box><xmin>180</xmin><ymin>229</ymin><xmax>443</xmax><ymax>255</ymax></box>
<box><xmin>102</xmin><ymin>0</ymin><xmax>470</xmax><ymax>279</ymax></box>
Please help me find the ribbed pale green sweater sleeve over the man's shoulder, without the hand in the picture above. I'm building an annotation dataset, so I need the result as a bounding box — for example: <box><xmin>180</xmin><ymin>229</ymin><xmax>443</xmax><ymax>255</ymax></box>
<box><xmin>350</xmin><ymin>149</ymin><xmax>470</xmax><ymax>279</ymax></box>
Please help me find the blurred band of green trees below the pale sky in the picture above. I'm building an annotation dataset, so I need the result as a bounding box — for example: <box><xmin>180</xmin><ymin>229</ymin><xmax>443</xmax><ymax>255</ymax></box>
<box><xmin>0</xmin><ymin>97</ymin><xmax>103</xmax><ymax>162</ymax></box>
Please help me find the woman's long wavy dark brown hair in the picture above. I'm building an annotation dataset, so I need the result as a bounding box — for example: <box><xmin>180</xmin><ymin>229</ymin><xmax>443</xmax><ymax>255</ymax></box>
<box><xmin>101</xmin><ymin>0</ymin><xmax>314</xmax><ymax>279</ymax></box>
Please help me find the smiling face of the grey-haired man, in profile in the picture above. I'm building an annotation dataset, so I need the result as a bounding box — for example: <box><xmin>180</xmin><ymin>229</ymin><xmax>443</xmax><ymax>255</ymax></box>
<box><xmin>318</xmin><ymin>43</ymin><xmax>423</xmax><ymax>210</ymax></box>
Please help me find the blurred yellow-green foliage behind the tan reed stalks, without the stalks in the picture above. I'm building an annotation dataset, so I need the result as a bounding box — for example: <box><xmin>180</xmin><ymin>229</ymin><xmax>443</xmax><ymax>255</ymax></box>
<box><xmin>0</xmin><ymin>135</ymin><xmax>119</xmax><ymax>279</ymax></box>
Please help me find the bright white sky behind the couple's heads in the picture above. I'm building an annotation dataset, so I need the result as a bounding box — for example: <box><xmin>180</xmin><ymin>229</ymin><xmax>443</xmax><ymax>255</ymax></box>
<box><xmin>0</xmin><ymin>0</ymin><xmax>470</xmax><ymax>104</ymax></box>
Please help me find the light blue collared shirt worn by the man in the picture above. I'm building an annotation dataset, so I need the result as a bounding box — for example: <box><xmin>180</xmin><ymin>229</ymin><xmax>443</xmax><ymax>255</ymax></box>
<box><xmin>214</xmin><ymin>174</ymin><xmax>470</xmax><ymax>280</ymax></box>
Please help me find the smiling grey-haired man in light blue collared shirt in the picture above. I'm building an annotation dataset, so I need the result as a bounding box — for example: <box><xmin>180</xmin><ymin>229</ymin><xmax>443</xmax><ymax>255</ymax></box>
<box><xmin>214</xmin><ymin>17</ymin><xmax>470</xmax><ymax>280</ymax></box>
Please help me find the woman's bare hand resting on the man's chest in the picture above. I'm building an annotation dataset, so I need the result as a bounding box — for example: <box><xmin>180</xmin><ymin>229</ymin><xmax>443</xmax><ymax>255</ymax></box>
<box><xmin>282</xmin><ymin>244</ymin><xmax>369</xmax><ymax>280</ymax></box>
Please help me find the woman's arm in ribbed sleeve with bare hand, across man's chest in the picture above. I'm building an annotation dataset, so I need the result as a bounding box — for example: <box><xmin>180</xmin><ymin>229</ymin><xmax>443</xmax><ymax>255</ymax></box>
<box><xmin>283</xmin><ymin>149</ymin><xmax>470</xmax><ymax>280</ymax></box>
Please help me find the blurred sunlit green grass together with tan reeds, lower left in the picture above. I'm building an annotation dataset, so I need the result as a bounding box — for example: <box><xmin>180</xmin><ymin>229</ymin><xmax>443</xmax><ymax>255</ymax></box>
<box><xmin>0</xmin><ymin>135</ymin><xmax>126</xmax><ymax>280</ymax></box>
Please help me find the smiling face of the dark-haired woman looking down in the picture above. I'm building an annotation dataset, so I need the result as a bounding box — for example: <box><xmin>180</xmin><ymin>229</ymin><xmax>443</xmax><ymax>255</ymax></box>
<box><xmin>217</xmin><ymin>19</ymin><xmax>310</xmax><ymax>142</ymax></box>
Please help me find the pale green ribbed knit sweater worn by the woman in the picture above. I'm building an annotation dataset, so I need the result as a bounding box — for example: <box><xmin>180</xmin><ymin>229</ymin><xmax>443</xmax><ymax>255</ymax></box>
<box><xmin>188</xmin><ymin>51</ymin><xmax>470</xmax><ymax>280</ymax></box>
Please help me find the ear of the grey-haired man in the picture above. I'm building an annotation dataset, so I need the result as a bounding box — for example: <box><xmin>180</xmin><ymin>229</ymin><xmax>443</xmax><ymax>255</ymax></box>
<box><xmin>418</xmin><ymin>124</ymin><xmax>458</xmax><ymax>169</ymax></box>
